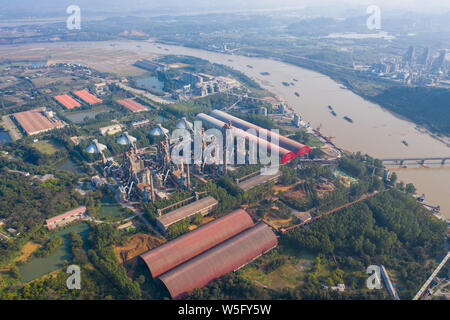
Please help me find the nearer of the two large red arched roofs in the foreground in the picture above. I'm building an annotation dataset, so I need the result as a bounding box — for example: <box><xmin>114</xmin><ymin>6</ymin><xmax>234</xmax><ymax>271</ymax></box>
<box><xmin>159</xmin><ymin>223</ymin><xmax>278</xmax><ymax>299</ymax></box>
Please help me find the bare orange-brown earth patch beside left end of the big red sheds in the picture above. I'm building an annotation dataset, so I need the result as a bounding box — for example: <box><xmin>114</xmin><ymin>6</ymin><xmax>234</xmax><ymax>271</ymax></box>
<box><xmin>114</xmin><ymin>233</ymin><xmax>164</xmax><ymax>263</ymax></box>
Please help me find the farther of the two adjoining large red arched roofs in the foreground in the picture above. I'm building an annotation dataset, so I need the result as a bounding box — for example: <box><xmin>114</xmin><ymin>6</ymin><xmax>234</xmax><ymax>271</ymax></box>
<box><xmin>141</xmin><ymin>209</ymin><xmax>253</xmax><ymax>278</ymax></box>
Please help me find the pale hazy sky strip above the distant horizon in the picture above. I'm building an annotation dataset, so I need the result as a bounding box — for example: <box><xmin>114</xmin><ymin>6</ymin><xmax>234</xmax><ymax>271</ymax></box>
<box><xmin>0</xmin><ymin>0</ymin><xmax>450</xmax><ymax>19</ymax></box>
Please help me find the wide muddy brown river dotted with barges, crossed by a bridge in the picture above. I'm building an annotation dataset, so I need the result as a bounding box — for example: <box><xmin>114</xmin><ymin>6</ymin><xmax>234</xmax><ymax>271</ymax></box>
<box><xmin>2</xmin><ymin>41</ymin><xmax>450</xmax><ymax>218</ymax></box>
